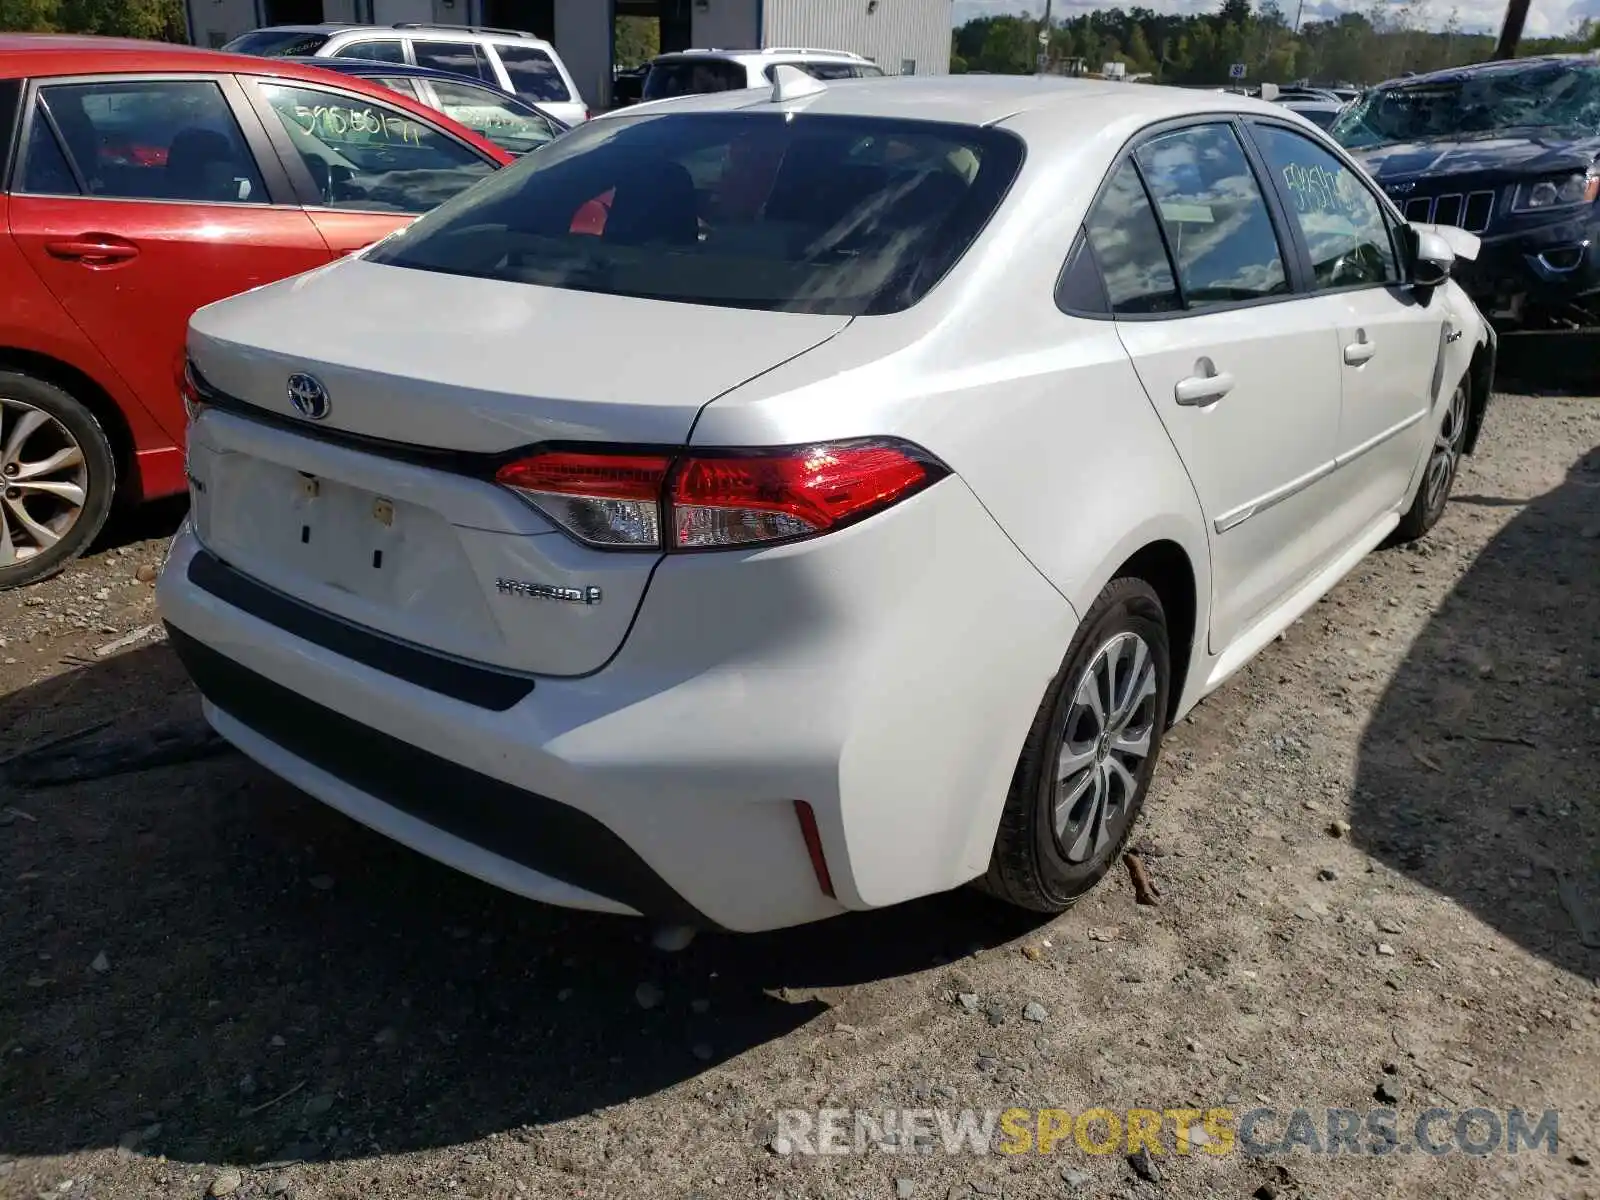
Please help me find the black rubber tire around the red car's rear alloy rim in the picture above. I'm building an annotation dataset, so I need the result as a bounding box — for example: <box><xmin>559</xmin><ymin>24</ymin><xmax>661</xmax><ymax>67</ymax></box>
<box><xmin>0</xmin><ymin>371</ymin><xmax>117</xmax><ymax>590</ymax></box>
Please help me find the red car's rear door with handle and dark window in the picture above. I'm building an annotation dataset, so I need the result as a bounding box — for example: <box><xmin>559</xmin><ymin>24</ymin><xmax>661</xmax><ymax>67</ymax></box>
<box><xmin>10</xmin><ymin>75</ymin><xmax>328</xmax><ymax>440</ymax></box>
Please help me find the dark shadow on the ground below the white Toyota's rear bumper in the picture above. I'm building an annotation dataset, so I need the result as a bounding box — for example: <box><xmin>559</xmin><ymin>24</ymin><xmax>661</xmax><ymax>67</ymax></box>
<box><xmin>0</xmin><ymin>643</ymin><xmax>1042</xmax><ymax>1163</ymax></box>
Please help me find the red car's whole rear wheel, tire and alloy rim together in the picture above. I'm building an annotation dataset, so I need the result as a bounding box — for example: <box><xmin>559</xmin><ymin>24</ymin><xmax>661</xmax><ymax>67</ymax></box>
<box><xmin>0</xmin><ymin>371</ymin><xmax>117</xmax><ymax>589</ymax></box>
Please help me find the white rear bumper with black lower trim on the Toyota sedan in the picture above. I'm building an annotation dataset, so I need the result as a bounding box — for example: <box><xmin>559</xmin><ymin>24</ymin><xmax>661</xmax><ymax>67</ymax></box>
<box><xmin>158</xmin><ymin>478</ymin><xmax>1075</xmax><ymax>930</ymax></box>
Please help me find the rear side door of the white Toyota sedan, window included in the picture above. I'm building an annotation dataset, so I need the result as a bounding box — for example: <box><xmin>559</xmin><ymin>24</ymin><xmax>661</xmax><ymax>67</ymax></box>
<box><xmin>1107</xmin><ymin>122</ymin><xmax>1339</xmax><ymax>653</ymax></box>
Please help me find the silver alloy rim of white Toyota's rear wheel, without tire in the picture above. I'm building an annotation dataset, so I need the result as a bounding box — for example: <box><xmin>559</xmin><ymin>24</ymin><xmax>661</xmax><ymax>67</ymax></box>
<box><xmin>1053</xmin><ymin>634</ymin><xmax>1157</xmax><ymax>866</ymax></box>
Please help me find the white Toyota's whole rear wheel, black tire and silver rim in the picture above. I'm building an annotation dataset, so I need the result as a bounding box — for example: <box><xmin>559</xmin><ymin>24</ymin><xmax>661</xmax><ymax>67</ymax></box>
<box><xmin>979</xmin><ymin>579</ymin><xmax>1171</xmax><ymax>912</ymax></box>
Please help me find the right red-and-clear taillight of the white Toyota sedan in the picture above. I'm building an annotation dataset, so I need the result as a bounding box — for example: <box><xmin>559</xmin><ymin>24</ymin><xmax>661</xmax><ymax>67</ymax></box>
<box><xmin>494</xmin><ymin>440</ymin><xmax>949</xmax><ymax>550</ymax></box>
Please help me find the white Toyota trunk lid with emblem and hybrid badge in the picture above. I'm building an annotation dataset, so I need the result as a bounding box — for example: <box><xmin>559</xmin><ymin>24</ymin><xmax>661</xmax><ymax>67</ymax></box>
<box><xmin>189</xmin><ymin>261</ymin><xmax>848</xmax><ymax>675</ymax></box>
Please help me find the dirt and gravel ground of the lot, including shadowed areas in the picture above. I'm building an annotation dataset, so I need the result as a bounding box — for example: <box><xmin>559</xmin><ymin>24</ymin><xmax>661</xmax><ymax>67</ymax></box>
<box><xmin>0</xmin><ymin>395</ymin><xmax>1600</xmax><ymax>1200</ymax></box>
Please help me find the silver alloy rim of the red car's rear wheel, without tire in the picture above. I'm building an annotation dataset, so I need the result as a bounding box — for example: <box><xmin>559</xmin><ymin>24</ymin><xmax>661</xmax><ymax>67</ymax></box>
<box><xmin>0</xmin><ymin>395</ymin><xmax>88</xmax><ymax>566</ymax></box>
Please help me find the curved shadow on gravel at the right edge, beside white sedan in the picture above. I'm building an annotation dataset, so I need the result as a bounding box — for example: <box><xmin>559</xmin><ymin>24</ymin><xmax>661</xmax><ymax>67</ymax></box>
<box><xmin>1350</xmin><ymin>448</ymin><xmax>1600</xmax><ymax>978</ymax></box>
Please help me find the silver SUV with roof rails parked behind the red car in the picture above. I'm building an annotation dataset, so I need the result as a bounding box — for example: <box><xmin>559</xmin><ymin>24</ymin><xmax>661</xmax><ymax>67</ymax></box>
<box><xmin>222</xmin><ymin>21</ymin><xmax>589</xmax><ymax>125</ymax></box>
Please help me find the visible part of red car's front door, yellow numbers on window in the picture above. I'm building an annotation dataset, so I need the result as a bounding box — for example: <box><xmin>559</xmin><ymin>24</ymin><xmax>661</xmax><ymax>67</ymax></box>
<box><xmin>233</xmin><ymin>78</ymin><xmax>499</xmax><ymax>254</ymax></box>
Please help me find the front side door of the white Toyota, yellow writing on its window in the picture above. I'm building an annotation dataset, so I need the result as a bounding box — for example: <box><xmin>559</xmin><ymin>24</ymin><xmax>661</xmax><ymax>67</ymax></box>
<box><xmin>1250</xmin><ymin>122</ymin><xmax>1446</xmax><ymax>538</ymax></box>
